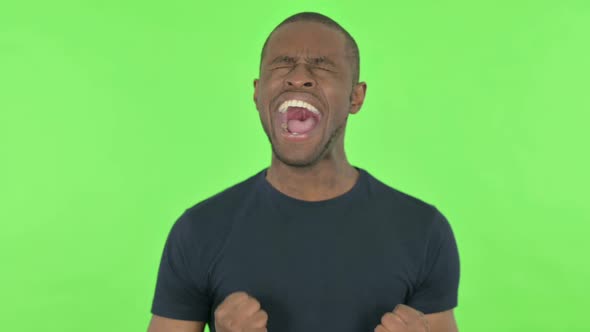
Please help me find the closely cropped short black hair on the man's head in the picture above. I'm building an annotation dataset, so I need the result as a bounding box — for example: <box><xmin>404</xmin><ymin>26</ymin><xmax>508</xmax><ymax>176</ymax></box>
<box><xmin>260</xmin><ymin>12</ymin><xmax>360</xmax><ymax>84</ymax></box>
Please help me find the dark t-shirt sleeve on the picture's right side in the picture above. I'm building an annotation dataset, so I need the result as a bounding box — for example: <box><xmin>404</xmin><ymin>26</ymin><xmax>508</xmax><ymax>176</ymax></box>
<box><xmin>407</xmin><ymin>208</ymin><xmax>460</xmax><ymax>314</ymax></box>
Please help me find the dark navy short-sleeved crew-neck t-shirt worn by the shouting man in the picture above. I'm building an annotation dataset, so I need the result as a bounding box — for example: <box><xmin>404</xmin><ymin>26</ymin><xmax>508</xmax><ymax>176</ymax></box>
<box><xmin>151</xmin><ymin>166</ymin><xmax>459</xmax><ymax>332</ymax></box>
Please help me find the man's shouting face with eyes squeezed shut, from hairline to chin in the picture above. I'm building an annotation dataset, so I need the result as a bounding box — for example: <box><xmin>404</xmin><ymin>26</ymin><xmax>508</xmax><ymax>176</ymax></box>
<box><xmin>254</xmin><ymin>22</ymin><xmax>366</xmax><ymax>167</ymax></box>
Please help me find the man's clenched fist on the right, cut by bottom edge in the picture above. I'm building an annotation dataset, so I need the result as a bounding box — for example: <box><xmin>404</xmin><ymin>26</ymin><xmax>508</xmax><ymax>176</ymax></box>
<box><xmin>375</xmin><ymin>304</ymin><xmax>430</xmax><ymax>332</ymax></box>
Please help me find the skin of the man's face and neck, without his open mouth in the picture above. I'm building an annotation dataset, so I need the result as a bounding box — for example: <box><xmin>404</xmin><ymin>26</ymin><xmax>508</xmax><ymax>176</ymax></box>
<box><xmin>254</xmin><ymin>22</ymin><xmax>367</xmax><ymax>201</ymax></box>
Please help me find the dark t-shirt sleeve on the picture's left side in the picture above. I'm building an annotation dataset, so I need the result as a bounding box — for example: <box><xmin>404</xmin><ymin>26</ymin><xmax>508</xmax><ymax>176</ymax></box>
<box><xmin>151</xmin><ymin>211</ymin><xmax>210</xmax><ymax>322</ymax></box>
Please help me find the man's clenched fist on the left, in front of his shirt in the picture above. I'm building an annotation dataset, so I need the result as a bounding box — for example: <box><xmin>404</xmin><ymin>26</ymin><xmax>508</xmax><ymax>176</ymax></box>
<box><xmin>214</xmin><ymin>292</ymin><xmax>268</xmax><ymax>332</ymax></box>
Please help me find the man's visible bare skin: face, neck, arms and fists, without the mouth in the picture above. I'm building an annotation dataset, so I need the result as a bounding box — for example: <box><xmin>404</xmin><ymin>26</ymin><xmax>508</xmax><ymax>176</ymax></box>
<box><xmin>149</xmin><ymin>22</ymin><xmax>457</xmax><ymax>332</ymax></box>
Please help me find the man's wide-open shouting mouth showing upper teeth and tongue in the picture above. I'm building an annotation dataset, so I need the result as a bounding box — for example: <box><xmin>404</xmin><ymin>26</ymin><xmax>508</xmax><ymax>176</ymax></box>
<box><xmin>278</xmin><ymin>99</ymin><xmax>322</xmax><ymax>138</ymax></box>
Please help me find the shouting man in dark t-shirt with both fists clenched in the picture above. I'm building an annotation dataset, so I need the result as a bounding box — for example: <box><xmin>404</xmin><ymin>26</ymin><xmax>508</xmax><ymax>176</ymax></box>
<box><xmin>149</xmin><ymin>13</ymin><xmax>459</xmax><ymax>332</ymax></box>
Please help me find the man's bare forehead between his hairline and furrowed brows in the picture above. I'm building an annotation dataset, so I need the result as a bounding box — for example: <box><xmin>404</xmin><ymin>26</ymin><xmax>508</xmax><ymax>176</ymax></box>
<box><xmin>265</xmin><ymin>22</ymin><xmax>347</xmax><ymax>61</ymax></box>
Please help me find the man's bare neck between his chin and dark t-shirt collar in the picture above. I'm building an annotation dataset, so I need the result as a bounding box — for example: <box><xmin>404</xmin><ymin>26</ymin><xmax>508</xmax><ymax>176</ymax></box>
<box><xmin>266</xmin><ymin>162</ymin><xmax>359</xmax><ymax>201</ymax></box>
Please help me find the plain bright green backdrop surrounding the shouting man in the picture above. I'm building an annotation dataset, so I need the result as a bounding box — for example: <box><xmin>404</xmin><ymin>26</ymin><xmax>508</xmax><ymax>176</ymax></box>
<box><xmin>0</xmin><ymin>0</ymin><xmax>590</xmax><ymax>332</ymax></box>
